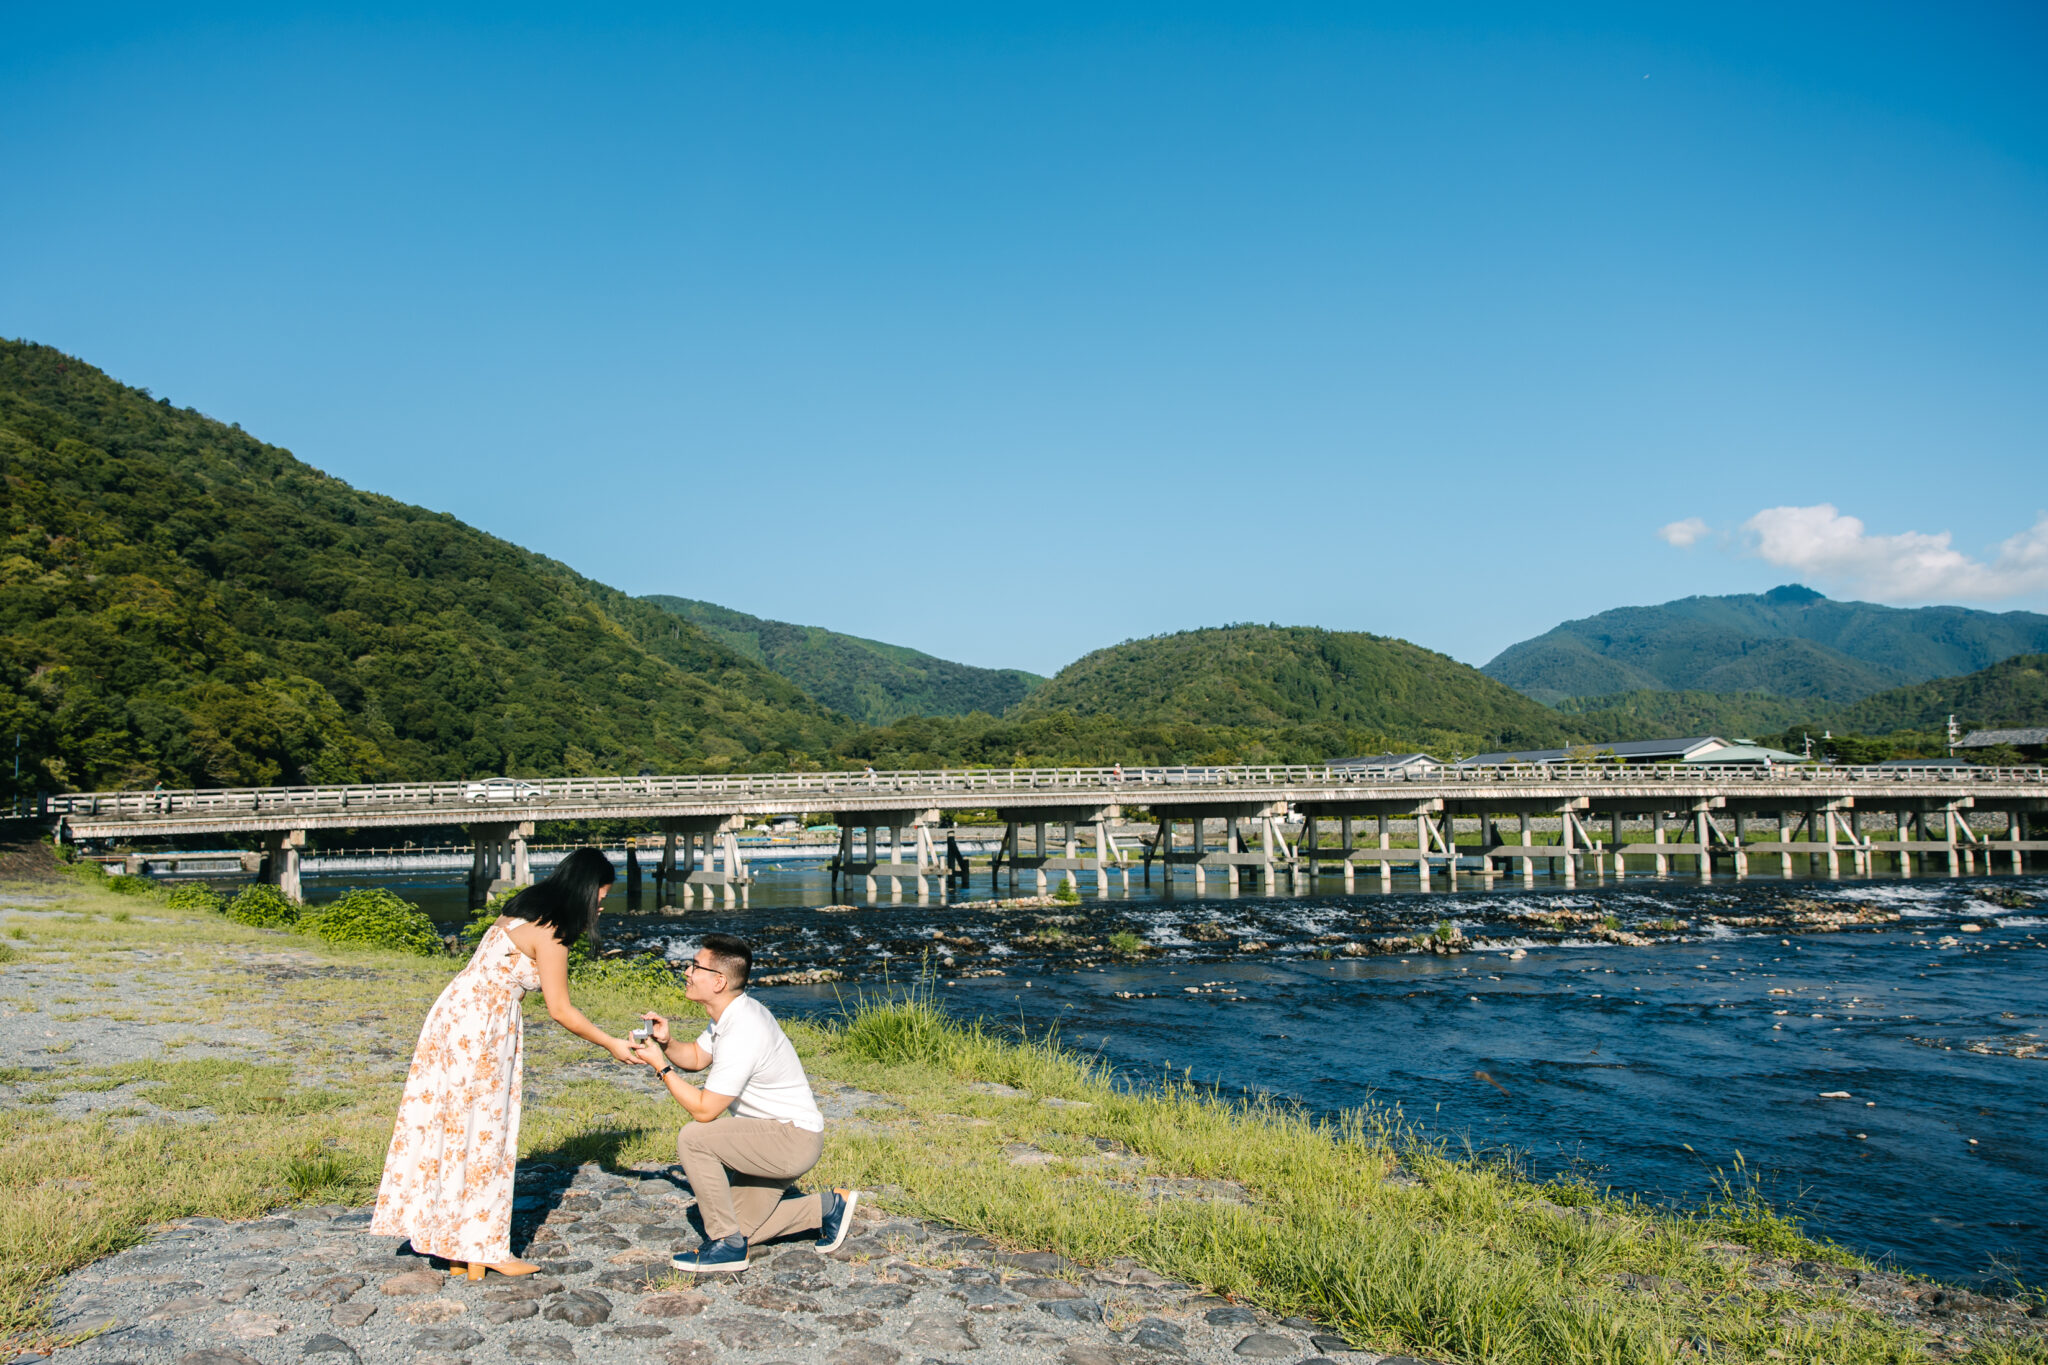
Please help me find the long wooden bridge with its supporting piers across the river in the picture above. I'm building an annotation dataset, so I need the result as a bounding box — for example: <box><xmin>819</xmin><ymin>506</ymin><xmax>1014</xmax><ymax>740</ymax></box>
<box><xmin>47</xmin><ymin>763</ymin><xmax>2048</xmax><ymax>905</ymax></box>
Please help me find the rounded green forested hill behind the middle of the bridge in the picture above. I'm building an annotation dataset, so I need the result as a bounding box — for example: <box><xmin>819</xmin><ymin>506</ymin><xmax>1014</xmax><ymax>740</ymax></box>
<box><xmin>1014</xmin><ymin>626</ymin><xmax>1575</xmax><ymax>751</ymax></box>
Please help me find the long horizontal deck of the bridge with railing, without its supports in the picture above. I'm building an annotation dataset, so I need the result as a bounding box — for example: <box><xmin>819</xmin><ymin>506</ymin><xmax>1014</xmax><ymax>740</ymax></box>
<box><xmin>47</xmin><ymin>763</ymin><xmax>2048</xmax><ymax>839</ymax></box>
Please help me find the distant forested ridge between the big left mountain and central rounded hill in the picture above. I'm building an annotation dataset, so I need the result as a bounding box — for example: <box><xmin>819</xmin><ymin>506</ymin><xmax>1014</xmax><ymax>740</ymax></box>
<box><xmin>641</xmin><ymin>593</ymin><xmax>1044</xmax><ymax>724</ymax></box>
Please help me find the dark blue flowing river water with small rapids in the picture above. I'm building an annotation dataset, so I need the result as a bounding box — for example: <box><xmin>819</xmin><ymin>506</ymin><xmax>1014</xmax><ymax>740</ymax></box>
<box><xmin>296</xmin><ymin>868</ymin><xmax>2048</xmax><ymax>1281</ymax></box>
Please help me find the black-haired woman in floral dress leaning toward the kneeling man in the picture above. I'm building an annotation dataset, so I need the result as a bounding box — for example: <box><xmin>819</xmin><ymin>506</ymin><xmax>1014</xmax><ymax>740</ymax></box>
<box><xmin>371</xmin><ymin>849</ymin><xmax>637</xmax><ymax>1279</ymax></box>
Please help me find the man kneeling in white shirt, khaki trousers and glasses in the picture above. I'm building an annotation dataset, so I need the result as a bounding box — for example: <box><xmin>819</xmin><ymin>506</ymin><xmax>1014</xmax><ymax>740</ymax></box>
<box><xmin>637</xmin><ymin>933</ymin><xmax>860</xmax><ymax>1275</ymax></box>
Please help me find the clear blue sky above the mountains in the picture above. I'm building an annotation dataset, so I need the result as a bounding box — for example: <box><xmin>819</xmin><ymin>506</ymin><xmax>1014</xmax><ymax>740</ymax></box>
<box><xmin>0</xmin><ymin>4</ymin><xmax>2048</xmax><ymax>673</ymax></box>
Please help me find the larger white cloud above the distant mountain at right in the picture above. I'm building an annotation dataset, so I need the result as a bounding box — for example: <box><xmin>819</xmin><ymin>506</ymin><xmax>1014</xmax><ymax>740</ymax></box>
<box><xmin>1736</xmin><ymin>503</ymin><xmax>2048</xmax><ymax>602</ymax></box>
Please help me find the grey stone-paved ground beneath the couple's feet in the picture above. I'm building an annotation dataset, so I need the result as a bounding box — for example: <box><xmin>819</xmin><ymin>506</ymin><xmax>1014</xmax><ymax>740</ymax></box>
<box><xmin>25</xmin><ymin>1166</ymin><xmax>1407</xmax><ymax>1365</ymax></box>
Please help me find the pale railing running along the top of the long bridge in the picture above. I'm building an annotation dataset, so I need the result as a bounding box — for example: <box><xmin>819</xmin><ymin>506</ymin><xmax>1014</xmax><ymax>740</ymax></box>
<box><xmin>47</xmin><ymin>763</ymin><xmax>2048</xmax><ymax>821</ymax></box>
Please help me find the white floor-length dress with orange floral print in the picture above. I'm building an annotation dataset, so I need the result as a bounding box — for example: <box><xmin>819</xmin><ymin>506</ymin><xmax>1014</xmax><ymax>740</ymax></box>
<box><xmin>371</xmin><ymin>919</ymin><xmax>541</xmax><ymax>1265</ymax></box>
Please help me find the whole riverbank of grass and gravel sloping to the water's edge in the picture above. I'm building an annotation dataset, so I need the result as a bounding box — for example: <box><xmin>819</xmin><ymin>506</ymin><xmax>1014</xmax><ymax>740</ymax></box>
<box><xmin>0</xmin><ymin>882</ymin><xmax>2048</xmax><ymax>1365</ymax></box>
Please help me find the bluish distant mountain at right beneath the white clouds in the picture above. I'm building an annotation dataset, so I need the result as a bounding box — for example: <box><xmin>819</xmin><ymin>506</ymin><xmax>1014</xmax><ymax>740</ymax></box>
<box><xmin>1483</xmin><ymin>585</ymin><xmax>2048</xmax><ymax>706</ymax></box>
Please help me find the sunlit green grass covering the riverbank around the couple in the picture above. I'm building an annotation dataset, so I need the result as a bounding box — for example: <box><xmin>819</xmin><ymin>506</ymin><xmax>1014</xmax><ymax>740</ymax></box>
<box><xmin>0</xmin><ymin>886</ymin><xmax>2042</xmax><ymax>1365</ymax></box>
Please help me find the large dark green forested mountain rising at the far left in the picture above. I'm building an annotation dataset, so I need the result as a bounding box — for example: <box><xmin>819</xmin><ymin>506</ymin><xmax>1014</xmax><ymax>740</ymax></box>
<box><xmin>0</xmin><ymin>342</ymin><xmax>848</xmax><ymax>790</ymax></box>
